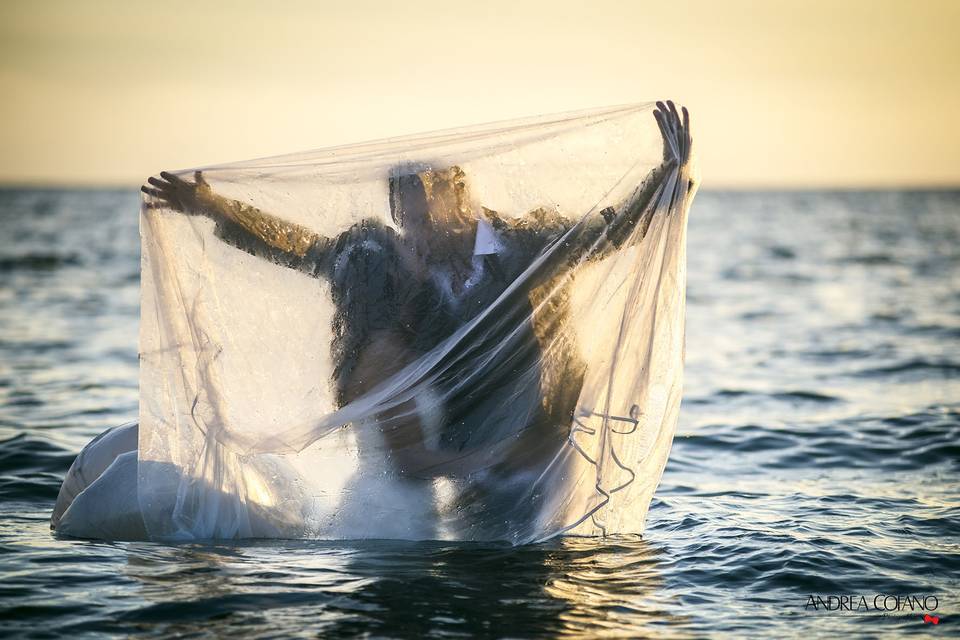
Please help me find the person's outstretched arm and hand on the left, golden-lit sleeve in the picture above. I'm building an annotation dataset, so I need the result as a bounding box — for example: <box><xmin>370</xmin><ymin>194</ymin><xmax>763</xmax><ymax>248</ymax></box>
<box><xmin>140</xmin><ymin>171</ymin><xmax>332</xmax><ymax>267</ymax></box>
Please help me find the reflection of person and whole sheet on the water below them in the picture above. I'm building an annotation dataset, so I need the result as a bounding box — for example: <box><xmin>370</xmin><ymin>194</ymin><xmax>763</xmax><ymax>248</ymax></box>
<box><xmin>116</xmin><ymin>536</ymin><xmax>676</xmax><ymax>638</ymax></box>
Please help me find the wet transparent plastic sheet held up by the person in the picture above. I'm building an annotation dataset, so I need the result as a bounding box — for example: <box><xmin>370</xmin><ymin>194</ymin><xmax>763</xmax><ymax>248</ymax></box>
<box><xmin>138</xmin><ymin>104</ymin><xmax>696</xmax><ymax>543</ymax></box>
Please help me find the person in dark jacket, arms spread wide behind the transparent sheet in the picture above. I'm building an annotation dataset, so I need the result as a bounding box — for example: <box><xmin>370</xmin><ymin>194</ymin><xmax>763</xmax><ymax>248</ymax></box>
<box><xmin>137</xmin><ymin>104</ymin><xmax>687</xmax><ymax>537</ymax></box>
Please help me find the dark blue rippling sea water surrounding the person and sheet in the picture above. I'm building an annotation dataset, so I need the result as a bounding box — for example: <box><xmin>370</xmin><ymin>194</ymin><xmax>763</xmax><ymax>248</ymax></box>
<box><xmin>0</xmin><ymin>190</ymin><xmax>960</xmax><ymax>638</ymax></box>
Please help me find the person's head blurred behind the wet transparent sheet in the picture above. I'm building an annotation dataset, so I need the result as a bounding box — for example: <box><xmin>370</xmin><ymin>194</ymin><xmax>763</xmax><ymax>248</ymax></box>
<box><xmin>389</xmin><ymin>165</ymin><xmax>476</xmax><ymax>261</ymax></box>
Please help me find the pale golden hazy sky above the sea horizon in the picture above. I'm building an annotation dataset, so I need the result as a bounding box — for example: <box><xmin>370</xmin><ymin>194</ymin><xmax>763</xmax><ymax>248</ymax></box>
<box><xmin>0</xmin><ymin>0</ymin><xmax>960</xmax><ymax>187</ymax></box>
